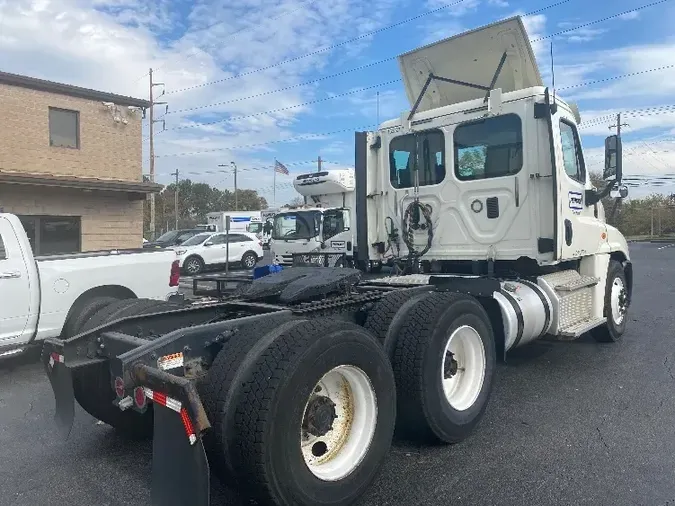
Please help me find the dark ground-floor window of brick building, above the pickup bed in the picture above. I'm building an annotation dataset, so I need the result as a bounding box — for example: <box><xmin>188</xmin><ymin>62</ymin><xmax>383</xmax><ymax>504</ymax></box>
<box><xmin>19</xmin><ymin>216</ymin><xmax>81</xmax><ymax>256</ymax></box>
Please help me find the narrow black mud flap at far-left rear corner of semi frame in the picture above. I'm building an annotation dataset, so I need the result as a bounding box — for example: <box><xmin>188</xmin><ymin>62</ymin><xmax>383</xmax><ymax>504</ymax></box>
<box><xmin>42</xmin><ymin>346</ymin><xmax>75</xmax><ymax>439</ymax></box>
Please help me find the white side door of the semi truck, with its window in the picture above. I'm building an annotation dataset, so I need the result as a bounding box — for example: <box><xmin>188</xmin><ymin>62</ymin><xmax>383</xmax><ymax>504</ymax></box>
<box><xmin>553</xmin><ymin>113</ymin><xmax>606</xmax><ymax>260</ymax></box>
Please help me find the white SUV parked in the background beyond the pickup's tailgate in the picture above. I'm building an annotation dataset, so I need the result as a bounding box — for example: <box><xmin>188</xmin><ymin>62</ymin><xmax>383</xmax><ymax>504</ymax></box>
<box><xmin>173</xmin><ymin>232</ymin><xmax>263</xmax><ymax>275</ymax></box>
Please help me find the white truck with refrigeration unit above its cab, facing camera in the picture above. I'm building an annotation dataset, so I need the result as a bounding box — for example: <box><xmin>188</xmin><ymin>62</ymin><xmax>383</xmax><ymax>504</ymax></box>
<box><xmin>270</xmin><ymin>169</ymin><xmax>364</xmax><ymax>265</ymax></box>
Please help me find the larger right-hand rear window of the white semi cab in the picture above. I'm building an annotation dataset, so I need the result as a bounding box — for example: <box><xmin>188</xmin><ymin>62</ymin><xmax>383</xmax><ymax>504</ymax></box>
<box><xmin>454</xmin><ymin>114</ymin><xmax>523</xmax><ymax>181</ymax></box>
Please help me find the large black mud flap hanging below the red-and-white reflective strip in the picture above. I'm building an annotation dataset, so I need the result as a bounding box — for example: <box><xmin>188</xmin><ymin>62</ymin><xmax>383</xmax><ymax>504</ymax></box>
<box><xmin>151</xmin><ymin>403</ymin><xmax>211</xmax><ymax>506</ymax></box>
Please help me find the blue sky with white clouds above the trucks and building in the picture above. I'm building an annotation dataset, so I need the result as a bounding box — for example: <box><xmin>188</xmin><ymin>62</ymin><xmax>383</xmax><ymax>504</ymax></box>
<box><xmin>0</xmin><ymin>0</ymin><xmax>675</xmax><ymax>204</ymax></box>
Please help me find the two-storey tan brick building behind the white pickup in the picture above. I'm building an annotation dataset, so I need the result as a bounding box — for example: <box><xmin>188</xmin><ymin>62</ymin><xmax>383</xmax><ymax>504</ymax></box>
<box><xmin>0</xmin><ymin>72</ymin><xmax>161</xmax><ymax>255</ymax></box>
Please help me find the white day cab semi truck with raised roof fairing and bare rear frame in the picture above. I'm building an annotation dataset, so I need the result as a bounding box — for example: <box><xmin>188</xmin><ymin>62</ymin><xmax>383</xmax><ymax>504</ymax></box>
<box><xmin>43</xmin><ymin>17</ymin><xmax>633</xmax><ymax>506</ymax></box>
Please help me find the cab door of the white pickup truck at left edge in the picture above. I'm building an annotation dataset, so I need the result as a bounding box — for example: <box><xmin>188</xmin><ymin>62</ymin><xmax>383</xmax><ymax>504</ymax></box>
<box><xmin>0</xmin><ymin>217</ymin><xmax>31</xmax><ymax>347</ymax></box>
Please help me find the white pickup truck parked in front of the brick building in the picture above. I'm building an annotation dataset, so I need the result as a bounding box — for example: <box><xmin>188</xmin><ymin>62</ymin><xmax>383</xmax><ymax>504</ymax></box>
<box><xmin>0</xmin><ymin>213</ymin><xmax>181</xmax><ymax>359</ymax></box>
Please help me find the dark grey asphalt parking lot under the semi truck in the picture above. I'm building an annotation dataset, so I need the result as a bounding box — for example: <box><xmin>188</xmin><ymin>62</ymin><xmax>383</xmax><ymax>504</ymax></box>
<box><xmin>0</xmin><ymin>243</ymin><xmax>675</xmax><ymax>506</ymax></box>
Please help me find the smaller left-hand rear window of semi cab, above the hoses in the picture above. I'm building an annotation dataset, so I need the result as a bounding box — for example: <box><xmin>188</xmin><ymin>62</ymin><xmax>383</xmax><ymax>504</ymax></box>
<box><xmin>389</xmin><ymin>130</ymin><xmax>445</xmax><ymax>189</ymax></box>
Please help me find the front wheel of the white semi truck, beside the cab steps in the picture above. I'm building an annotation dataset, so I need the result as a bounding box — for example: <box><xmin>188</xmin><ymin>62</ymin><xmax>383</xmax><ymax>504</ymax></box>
<box><xmin>591</xmin><ymin>260</ymin><xmax>628</xmax><ymax>343</ymax></box>
